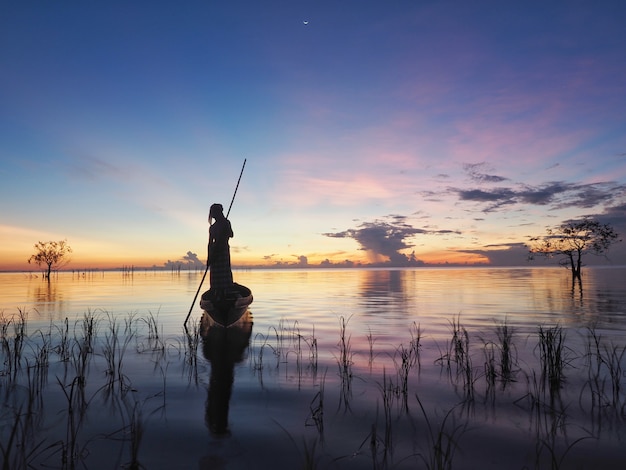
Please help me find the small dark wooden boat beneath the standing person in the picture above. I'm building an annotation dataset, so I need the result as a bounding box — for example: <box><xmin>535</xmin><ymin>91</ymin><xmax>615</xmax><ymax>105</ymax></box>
<box><xmin>200</xmin><ymin>282</ymin><xmax>252</xmax><ymax>326</ymax></box>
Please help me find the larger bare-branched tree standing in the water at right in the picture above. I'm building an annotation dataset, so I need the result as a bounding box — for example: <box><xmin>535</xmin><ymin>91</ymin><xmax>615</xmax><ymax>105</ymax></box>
<box><xmin>529</xmin><ymin>218</ymin><xmax>621</xmax><ymax>281</ymax></box>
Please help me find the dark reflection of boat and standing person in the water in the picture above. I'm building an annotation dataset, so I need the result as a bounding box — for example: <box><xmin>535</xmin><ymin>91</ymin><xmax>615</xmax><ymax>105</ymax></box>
<box><xmin>200</xmin><ymin>311</ymin><xmax>252</xmax><ymax>437</ymax></box>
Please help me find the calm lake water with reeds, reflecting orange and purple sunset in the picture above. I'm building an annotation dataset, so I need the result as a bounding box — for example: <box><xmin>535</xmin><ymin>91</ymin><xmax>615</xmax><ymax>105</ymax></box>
<box><xmin>0</xmin><ymin>267</ymin><xmax>626</xmax><ymax>469</ymax></box>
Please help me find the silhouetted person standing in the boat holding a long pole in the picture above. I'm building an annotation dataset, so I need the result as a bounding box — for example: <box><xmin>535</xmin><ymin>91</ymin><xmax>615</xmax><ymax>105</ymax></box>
<box><xmin>207</xmin><ymin>204</ymin><xmax>233</xmax><ymax>299</ymax></box>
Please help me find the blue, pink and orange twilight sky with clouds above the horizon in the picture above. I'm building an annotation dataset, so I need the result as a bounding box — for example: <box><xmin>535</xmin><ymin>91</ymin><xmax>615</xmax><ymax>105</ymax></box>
<box><xmin>0</xmin><ymin>0</ymin><xmax>626</xmax><ymax>270</ymax></box>
